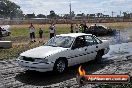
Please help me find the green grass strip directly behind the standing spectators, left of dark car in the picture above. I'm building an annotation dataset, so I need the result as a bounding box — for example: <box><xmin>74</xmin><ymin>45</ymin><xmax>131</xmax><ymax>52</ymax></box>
<box><xmin>11</xmin><ymin>25</ymin><xmax>70</xmax><ymax>39</ymax></box>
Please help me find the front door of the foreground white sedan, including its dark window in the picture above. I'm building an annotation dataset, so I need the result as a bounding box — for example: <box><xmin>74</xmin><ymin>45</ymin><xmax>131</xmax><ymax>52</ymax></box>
<box><xmin>68</xmin><ymin>36</ymin><xmax>86</xmax><ymax>65</ymax></box>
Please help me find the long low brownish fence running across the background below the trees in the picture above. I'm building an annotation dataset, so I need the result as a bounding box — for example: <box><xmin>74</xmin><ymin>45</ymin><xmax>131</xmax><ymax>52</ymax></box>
<box><xmin>0</xmin><ymin>18</ymin><xmax>132</xmax><ymax>25</ymax></box>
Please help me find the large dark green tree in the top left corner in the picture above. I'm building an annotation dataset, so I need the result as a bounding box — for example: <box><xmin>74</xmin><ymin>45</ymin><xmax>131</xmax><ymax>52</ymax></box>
<box><xmin>0</xmin><ymin>0</ymin><xmax>23</xmax><ymax>19</ymax></box>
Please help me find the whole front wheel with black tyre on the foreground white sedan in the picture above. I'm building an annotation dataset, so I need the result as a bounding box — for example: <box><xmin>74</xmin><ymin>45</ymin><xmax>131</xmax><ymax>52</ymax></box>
<box><xmin>53</xmin><ymin>59</ymin><xmax>67</xmax><ymax>73</ymax></box>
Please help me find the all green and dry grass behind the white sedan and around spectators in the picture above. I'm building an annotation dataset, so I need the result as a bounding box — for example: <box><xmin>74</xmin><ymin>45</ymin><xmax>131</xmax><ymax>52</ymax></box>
<box><xmin>0</xmin><ymin>22</ymin><xmax>132</xmax><ymax>59</ymax></box>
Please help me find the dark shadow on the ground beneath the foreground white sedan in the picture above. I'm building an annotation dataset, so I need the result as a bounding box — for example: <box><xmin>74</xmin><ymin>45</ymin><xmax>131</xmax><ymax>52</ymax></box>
<box><xmin>15</xmin><ymin>58</ymin><xmax>113</xmax><ymax>86</ymax></box>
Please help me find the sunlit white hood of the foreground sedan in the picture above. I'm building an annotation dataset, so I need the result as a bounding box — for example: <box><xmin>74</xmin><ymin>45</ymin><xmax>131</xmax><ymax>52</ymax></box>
<box><xmin>20</xmin><ymin>46</ymin><xmax>67</xmax><ymax>58</ymax></box>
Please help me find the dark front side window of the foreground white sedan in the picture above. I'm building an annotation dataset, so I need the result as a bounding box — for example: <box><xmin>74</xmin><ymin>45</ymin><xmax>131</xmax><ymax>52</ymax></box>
<box><xmin>73</xmin><ymin>36</ymin><xmax>85</xmax><ymax>49</ymax></box>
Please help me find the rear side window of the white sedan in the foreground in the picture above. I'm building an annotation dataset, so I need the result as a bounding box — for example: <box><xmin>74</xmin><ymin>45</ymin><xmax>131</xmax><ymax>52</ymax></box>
<box><xmin>85</xmin><ymin>36</ymin><xmax>98</xmax><ymax>46</ymax></box>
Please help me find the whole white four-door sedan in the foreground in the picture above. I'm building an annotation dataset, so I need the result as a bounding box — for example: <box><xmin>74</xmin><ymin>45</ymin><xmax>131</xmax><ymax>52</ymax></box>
<box><xmin>18</xmin><ymin>33</ymin><xmax>109</xmax><ymax>73</ymax></box>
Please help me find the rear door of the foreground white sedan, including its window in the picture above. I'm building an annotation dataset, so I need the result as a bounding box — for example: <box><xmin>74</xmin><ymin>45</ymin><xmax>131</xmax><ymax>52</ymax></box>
<box><xmin>85</xmin><ymin>35</ymin><xmax>98</xmax><ymax>62</ymax></box>
